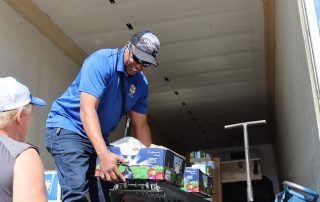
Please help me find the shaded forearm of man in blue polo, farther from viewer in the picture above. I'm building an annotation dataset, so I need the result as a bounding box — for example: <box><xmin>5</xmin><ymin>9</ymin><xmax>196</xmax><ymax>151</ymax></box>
<box><xmin>129</xmin><ymin>110</ymin><xmax>152</xmax><ymax>147</ymax></box>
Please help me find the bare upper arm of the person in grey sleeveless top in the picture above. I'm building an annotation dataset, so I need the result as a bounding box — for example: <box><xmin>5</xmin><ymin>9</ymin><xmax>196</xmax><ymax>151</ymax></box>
<box><xmin>12</xmin><ymin>148</ymin><xmax>48</xmax><ymax>202</ymax></box>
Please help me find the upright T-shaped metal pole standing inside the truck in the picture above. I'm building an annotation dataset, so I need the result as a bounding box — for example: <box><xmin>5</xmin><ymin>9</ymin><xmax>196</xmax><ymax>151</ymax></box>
<box><xmin>224</xmin><ymin>120</ymin><xmax>266</xmax><ymax>202</ymax></box>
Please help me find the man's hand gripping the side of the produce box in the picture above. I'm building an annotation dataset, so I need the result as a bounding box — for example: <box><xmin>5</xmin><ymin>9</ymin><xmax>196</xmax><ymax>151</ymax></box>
<box><xmin>98</xmin><ymin>151</ymin><xmax>127</xmax><ymax>182</ymax></box>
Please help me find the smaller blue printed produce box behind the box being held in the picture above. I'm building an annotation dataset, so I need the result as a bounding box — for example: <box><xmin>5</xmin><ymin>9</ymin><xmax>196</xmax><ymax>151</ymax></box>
<box><xmin>181</xmin><ymin>167</ymin><xmax>213</xmax><ymax>196</ymax></box>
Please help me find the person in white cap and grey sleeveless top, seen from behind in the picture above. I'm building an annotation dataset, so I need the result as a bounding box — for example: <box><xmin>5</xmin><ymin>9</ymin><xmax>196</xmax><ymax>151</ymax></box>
<box><xmin>0</xmin><ymin>77</ymin><xmax>48</xmax><ymax>202</ymax></box>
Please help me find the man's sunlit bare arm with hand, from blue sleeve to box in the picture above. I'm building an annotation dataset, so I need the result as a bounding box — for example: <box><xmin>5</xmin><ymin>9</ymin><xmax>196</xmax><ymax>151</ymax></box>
<box><xmin>80</xmin><ymin>92</ymin><xmax>125</xmax><ymax>181</ymax></box>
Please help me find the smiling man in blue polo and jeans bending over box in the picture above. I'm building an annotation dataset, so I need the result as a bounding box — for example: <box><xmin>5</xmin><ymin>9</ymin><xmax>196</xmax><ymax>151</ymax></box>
<box><xmin>45</xmin><ymin>31</ymin><xmax>160</xmax><ymax>202</ymax></box>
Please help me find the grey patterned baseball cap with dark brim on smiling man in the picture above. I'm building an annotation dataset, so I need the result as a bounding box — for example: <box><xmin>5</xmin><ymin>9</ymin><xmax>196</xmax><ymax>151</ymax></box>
<box><xmin>130</xmin><ymin>31</ymin><xmax>160</xmax><ymax>66</ymax></box>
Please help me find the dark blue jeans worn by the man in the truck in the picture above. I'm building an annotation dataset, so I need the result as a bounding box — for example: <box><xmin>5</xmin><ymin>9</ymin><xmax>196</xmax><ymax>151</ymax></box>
<box><xmin>45</xmin><ymin>128</ymin><xmax>113</xmax><ymax>202</ymax></box>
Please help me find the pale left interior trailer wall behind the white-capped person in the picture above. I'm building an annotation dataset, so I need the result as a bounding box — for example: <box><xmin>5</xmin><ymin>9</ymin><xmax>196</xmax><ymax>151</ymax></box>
<box><xmin>0</xmin><ymin>1</ymin><xmax>79</xmax><ymax>169</ymax></box>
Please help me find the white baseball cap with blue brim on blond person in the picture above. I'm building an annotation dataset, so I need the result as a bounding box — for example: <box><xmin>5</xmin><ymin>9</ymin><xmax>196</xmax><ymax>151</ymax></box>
<box><xmin>0</xmin><ymin>77</ymin><xmax>47</xmax><ymax>112</ymax></box>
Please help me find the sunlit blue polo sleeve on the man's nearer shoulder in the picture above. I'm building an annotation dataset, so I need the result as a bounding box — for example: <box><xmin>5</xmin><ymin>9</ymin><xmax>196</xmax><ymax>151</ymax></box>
<box><xmin>79</xmin><ymin>53</ymin><xmax>114</xmax><ymax>100</ymax></box>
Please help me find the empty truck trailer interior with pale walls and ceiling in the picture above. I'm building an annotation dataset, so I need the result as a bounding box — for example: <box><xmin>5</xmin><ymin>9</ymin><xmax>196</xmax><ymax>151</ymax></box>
<box><xmin>0</xmin><ymin>0</ymin><xmax>320</xmax><ymax>202</ymax></box>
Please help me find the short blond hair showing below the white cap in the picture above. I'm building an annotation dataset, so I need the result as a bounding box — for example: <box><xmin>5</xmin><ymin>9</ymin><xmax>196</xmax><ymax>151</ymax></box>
<box><xmin>0</xmin><ymin>103</ymin><xmax>32</xmax><ymax>128</ymax></box>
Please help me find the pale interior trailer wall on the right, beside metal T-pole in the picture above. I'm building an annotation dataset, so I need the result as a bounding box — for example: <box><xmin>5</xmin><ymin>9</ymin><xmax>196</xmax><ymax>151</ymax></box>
<box><xmin>275</xmin><ymin>0</ymin><xmax>320</xmax><ymax>192</ymax></box>
